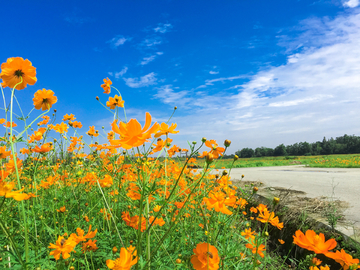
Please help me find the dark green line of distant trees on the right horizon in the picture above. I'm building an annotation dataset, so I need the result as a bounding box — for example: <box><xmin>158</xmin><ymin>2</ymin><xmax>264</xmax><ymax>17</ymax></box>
<box><xmin>235</xmin><ymin>134</ymin><xmax>360</xmax><ymax>158</ymax></box>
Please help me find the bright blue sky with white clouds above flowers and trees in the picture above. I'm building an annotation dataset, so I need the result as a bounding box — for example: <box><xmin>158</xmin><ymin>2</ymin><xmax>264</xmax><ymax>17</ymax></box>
<box><xmin>0</xmin><ymin>0</ymin><xmax>360</xmax><ymax>153</ymax></box>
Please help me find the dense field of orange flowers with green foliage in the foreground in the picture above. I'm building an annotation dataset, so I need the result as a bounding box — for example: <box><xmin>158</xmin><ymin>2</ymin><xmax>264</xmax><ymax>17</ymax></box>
<box><xmin>0</xmin><ymin>57</ymin><xmax>360</xmax><ymax>270</ymax></box>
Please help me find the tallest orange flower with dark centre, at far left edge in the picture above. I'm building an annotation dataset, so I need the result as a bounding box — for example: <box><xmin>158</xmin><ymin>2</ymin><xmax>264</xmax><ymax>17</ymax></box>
<box><xmin>0</xmin><ymin>57</ymin><xmax>37</xmax><ymax>90</ymax></box>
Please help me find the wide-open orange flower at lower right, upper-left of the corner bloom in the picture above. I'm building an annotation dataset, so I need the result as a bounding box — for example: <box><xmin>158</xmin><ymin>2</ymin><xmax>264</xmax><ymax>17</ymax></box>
<box><xmin>293</xmin><ymin>230</ymin><xmax>337</xmax><ymax>254</ymax></box>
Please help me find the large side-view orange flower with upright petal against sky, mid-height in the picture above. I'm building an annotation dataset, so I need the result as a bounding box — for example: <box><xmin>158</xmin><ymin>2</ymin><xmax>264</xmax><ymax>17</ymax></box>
<box><xmin>110</xmin><ymin>112</ymin><xmax>159</xmax><ymax>149</ymax></box>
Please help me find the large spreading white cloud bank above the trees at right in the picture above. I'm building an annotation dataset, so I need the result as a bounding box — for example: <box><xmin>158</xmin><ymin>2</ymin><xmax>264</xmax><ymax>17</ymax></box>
<box><xmin>158</xmin><ymin>12</ymin><xmax>360</xmax><ymax>153</ymax></box>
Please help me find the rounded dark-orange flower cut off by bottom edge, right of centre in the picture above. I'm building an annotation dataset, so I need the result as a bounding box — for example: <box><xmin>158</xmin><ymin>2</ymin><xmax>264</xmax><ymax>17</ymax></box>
<box><xmin>190</xmin><ymin>243</ymin><xmax>220</xmax><ymax>270</ymax></box>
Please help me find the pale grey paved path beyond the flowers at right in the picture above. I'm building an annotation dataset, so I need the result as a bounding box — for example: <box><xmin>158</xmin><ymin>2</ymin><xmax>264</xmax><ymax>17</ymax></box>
<box><xmin>224</xmin><ymin>165</ymin><xmax>360</xmax><ymax>241</ymax></box>
